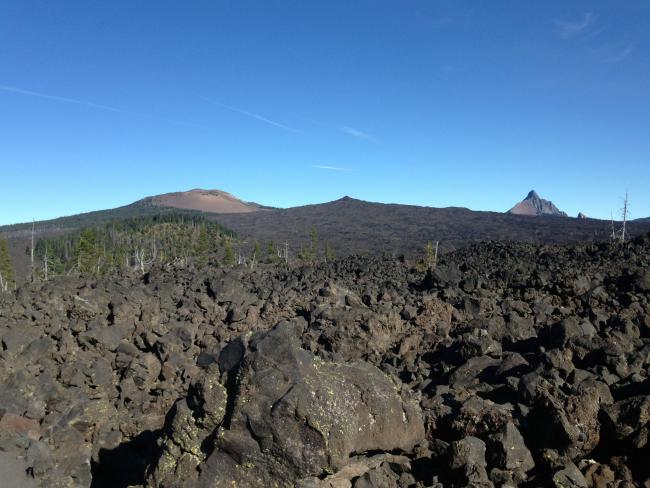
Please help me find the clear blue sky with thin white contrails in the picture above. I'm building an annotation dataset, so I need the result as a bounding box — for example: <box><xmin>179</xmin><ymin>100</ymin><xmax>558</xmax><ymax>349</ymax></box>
<box><xmin>0</xmin><ymin>0</ymin><xmax>650</xmax><ymax>224</ymax></box>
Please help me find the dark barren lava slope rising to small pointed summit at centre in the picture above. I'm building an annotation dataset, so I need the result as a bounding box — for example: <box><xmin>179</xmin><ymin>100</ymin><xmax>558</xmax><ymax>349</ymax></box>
<box><xmin>218</xmin><ymin>197</ymin><xmax>650</xmax><ymax>255</ymax></box>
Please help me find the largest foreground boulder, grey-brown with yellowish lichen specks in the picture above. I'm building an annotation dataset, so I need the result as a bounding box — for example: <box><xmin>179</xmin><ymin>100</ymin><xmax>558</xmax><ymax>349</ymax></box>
<box><xmin>146</xmin><ymin>322</ymin><xmax>424</xmax><ymax>486</ymax></box>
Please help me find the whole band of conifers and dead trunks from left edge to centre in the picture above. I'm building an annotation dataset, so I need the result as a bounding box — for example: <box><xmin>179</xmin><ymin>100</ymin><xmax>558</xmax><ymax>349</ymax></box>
<box><xmin>0</xmin><ymin>212</ymin><xmax>336</xmax><ymax>291</ymax></box>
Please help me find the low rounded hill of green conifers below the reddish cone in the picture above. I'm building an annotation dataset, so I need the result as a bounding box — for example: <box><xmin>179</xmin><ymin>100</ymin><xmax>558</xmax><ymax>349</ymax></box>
<box><xmin>32</xmin><ymin>214</ymin><xmax>236</xmax><ymax>279</ymax></box>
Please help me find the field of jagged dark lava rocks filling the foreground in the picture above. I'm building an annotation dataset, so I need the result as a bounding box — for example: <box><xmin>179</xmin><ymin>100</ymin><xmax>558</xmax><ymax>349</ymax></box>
<box><xmin>0</xmin><ymin>235</ymin><xmax>650</xmax><ymax>488</ymax></box>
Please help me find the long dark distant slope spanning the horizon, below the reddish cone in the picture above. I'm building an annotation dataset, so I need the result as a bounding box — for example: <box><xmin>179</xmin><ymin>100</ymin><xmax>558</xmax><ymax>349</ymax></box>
<box><xmin>0</xmin><ymin>193</ymin><xmax>650</xmax><ymax>276</ymax></box>
